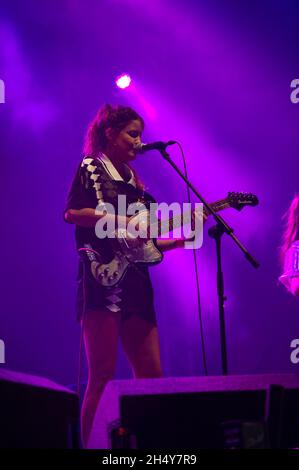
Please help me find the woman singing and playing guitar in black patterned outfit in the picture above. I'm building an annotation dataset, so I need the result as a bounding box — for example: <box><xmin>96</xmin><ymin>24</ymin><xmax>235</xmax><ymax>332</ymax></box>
<box><xmin>64</xmin><ymin>105</ymin><xmax>189</xmax><ymax>446</ymax></box>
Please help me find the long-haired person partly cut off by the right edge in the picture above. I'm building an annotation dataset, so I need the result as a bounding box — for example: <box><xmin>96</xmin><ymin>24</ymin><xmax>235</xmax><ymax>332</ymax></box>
<box><xmin>279</xmin><ymin>194</ymin><xmax>299</xmax><ymax>297</ymax></box>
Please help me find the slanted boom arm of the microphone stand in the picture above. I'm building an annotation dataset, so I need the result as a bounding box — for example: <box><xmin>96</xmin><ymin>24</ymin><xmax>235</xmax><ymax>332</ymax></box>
<box><xmin>159</xmin><ymin>149</ymin><xmax>260</xmax><ymax>268</ymax></box>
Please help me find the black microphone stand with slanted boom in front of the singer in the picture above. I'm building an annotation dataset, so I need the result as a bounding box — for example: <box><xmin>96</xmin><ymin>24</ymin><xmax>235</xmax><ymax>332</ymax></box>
<box><xmin>159</xmin><ymin>144</ymin><xmax>259</xmax><ymax>375</ymax></box>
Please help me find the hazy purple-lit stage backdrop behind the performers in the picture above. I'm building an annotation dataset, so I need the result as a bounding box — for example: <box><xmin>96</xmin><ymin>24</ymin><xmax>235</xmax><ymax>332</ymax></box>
<box><xmin>0</xmin><ymin>0</ymin><xmax>299</xmax><ymax>384</ymax></box>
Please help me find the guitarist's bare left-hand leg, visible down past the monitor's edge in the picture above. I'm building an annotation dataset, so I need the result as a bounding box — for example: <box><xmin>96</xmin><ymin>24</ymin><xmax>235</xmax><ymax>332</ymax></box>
<box><xmin>81</xmin><ymin>310</ymin><xmax>120</xmax><ymax>447</ymax></box>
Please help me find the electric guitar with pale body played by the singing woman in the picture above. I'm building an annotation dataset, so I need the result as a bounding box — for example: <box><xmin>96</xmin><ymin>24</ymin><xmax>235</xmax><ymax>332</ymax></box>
<box><xmin>79</xmin><ymin>192</ymin><xmax>258</xmax><ymax>288</ymax></box>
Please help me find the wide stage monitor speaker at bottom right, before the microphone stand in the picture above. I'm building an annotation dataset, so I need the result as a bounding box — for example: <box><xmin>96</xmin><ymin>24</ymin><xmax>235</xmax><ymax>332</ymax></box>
<box><xmin>88</xmin><ymin>374</ymin><xmax>299</xmax><ymax>449</ymax></box>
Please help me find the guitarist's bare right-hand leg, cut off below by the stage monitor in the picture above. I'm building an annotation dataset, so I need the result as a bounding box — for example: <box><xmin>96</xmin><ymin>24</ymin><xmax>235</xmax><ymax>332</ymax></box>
<box><xmin>121</xmin><ymin>315</ymin><xmax>163</xmax><ymax>378</ymax></box>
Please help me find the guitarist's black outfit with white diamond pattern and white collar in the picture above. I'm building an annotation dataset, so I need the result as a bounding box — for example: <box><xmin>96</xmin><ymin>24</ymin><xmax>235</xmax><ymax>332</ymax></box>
<box><xmin>64</xmin><ymin>153</ymin><xmax>156</xmax><ymax>324</ymax></box>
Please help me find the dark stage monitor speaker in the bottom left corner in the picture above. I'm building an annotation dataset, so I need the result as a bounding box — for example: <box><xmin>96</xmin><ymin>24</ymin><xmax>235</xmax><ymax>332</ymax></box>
<box><xmin>0</xmin><ymin>369</ymin><xmax>79</xmax><ymax>449</ymax></box>
